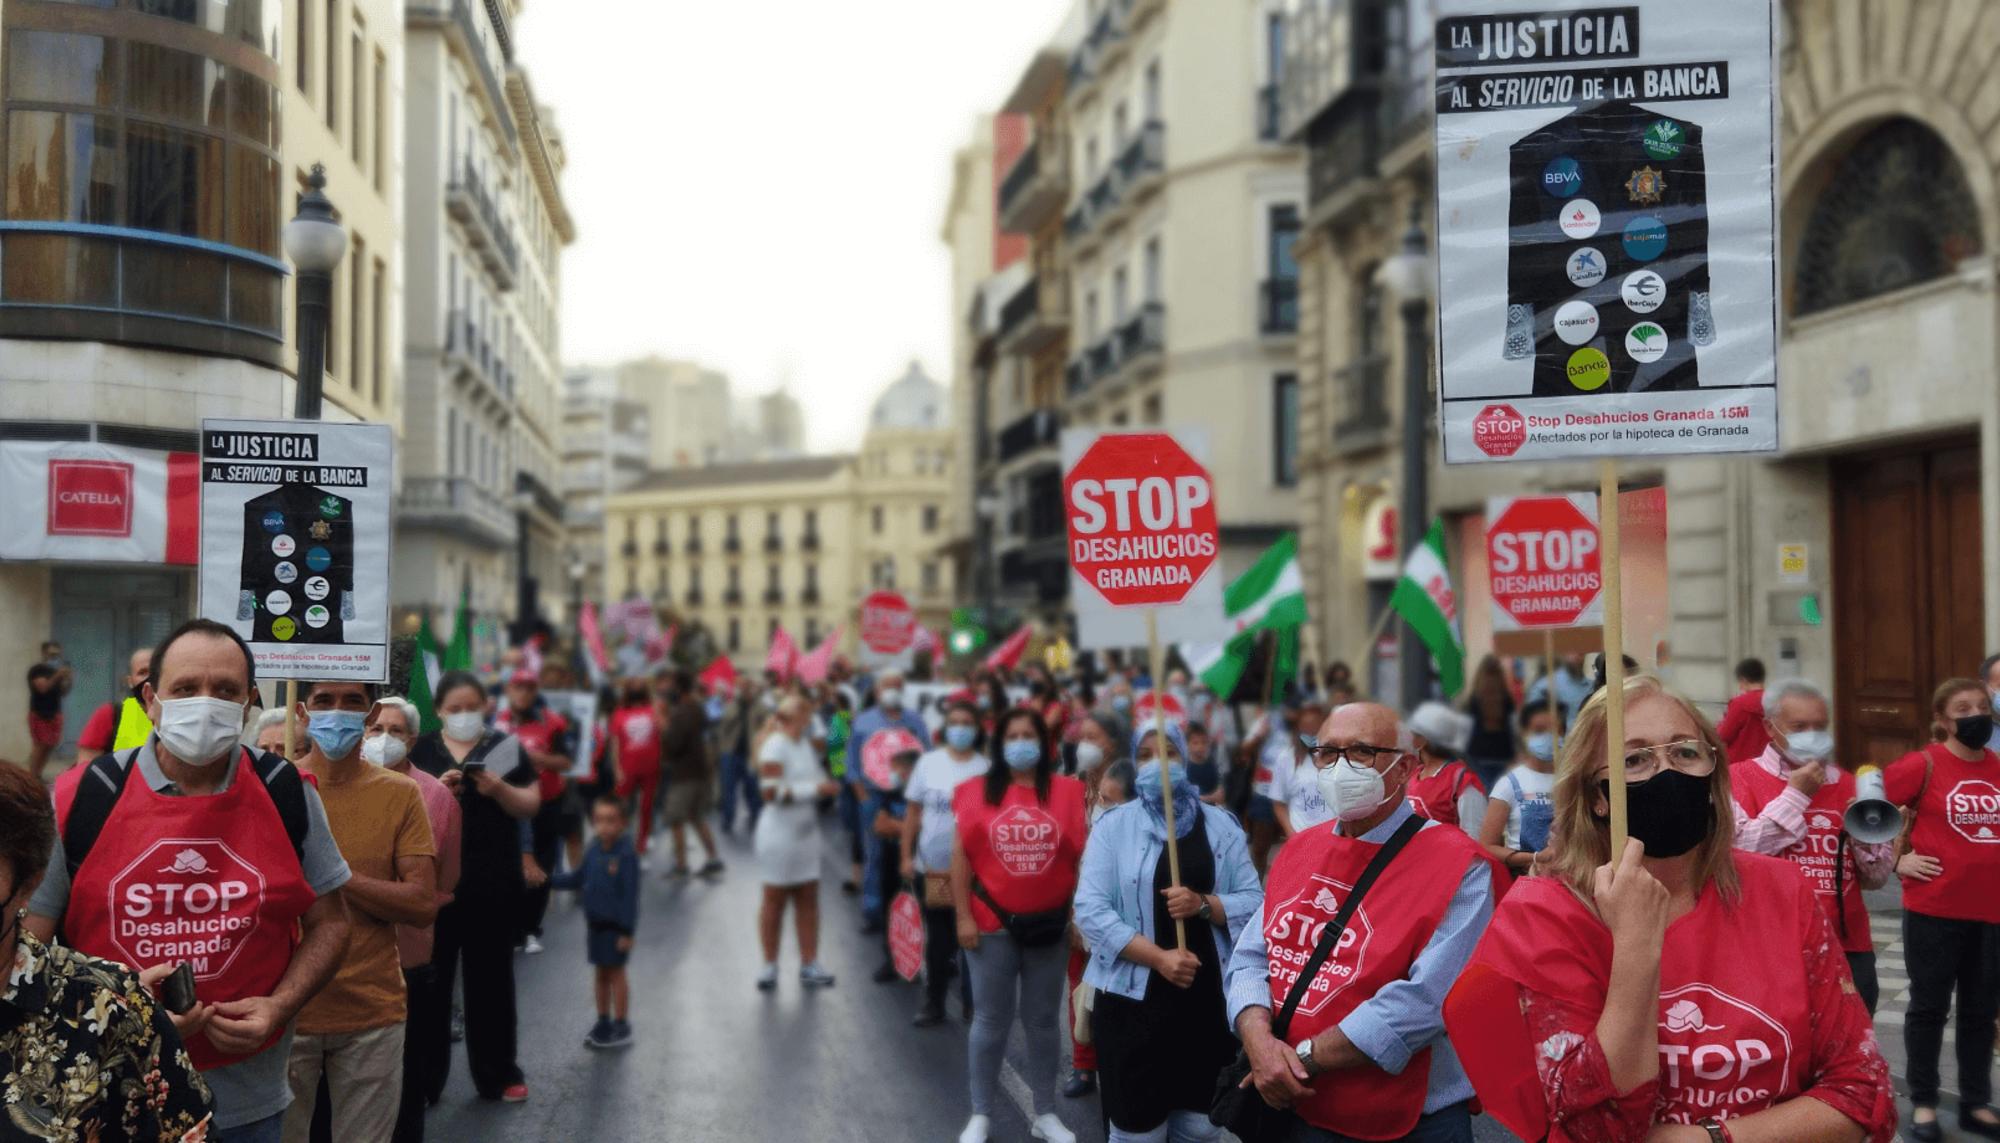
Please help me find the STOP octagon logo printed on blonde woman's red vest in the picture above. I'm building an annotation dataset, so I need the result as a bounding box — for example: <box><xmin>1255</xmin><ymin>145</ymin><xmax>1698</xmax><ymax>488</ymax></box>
<box><xmin>1660</xmin><ymin>983</ymin><xmax>1792</xmax><ymax>1123</ymax></box>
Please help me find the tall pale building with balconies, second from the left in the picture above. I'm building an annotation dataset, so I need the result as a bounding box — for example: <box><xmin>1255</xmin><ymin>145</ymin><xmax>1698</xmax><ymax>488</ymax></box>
<box><xmin>392</xmin><ymin>0</ymin><xmax>574</xmax><ymax>637</ymax></box>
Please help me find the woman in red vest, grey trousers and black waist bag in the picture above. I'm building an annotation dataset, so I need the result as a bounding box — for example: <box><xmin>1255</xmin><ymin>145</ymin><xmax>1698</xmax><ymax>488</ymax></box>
<box><xmin>952</xmin><ymin>707</ymin><xmax>1084</xmax><ymax>1143</ymax></box>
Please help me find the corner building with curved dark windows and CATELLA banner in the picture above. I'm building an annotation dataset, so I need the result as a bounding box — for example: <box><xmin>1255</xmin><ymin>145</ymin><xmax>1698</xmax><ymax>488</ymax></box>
<box><xmin>0</xmin><ymin>0</ymin><xmax>402</xmax><ymax>757</ymax></box>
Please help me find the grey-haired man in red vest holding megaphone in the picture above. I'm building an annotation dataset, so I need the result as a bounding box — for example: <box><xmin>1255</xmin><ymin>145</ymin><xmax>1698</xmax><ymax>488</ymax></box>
<box><xmin>1730</xmin><ymin>679</ymin><xmax>1896</xmax><ymax>1013</ymax></box>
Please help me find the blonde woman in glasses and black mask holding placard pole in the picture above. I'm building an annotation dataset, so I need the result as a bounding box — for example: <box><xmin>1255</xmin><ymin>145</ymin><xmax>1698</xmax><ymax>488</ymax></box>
<box><xmin>1446</xmin><ymin>675</ymin><xmax>1896</xmax><ymax>1143</ymax></box>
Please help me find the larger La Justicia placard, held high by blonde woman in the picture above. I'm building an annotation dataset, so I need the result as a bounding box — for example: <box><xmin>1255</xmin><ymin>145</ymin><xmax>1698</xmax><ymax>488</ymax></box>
<box><xmin>1436</xmin><ymin>0</ymin><xmax>1778</xmax><ymax>464</ymax></box>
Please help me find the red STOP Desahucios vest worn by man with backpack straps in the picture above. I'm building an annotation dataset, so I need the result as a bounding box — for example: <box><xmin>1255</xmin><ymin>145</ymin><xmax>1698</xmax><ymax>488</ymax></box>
<box><xmin>62</xmin><ymin>751</ymin><xmax>314</xmax><ymax>1071</ymax></box>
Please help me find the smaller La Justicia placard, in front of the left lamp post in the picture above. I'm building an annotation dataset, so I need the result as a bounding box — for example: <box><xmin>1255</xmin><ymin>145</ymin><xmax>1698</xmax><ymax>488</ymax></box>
<box><xmin>202</xmin><ymin>420</ymin><xmax>396</xmax><ymax>683</ymax></box>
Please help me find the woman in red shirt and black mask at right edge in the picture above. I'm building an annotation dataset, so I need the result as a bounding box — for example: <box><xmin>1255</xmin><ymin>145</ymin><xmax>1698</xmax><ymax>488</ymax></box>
<box><xmin>1884</xmin><ymin>679</ymin><xmax>2000</xmax><ymax>1143</ymax></box>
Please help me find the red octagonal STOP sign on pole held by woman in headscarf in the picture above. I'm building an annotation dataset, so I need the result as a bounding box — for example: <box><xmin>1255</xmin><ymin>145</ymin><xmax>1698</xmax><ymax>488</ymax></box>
<box><xmin>1062</xmin><ymin>432</ymin><xmax>1220</xmax><ymax>607</ymax></box>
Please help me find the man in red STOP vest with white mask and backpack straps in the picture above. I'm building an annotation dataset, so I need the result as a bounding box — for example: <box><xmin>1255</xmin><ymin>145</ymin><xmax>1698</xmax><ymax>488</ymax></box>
<box><xmin>26</xmin><ymin>619</ymin><xmax>348</xmax><ymax>1143</ymax></box>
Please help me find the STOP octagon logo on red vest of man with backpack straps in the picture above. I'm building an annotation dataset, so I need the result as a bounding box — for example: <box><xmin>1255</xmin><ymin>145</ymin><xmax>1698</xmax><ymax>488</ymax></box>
<box><xmin>108</xmin><ymin>837</ymin><xmax>264</xmax><ymax>981</ymax></box>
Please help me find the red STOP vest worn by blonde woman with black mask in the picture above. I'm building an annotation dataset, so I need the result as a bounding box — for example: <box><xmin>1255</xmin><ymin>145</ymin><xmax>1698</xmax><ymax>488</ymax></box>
<box><xmin>1472</xmin><ymin>849</ymin><xmax>1824</xmax><ymax>1141</ymax></box>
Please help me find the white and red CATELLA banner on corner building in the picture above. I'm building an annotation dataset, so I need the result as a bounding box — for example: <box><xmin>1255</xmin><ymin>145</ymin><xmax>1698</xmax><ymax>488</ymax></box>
<box><xmin>0</xmin><ymin>440</ymin><xmax>202</xmax><ymax>564</ymax></box>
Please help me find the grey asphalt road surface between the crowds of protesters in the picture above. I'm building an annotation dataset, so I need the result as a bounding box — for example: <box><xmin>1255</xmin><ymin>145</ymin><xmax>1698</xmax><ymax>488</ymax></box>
<box><xmin>428</xmin><ymin>819</ymin><xmax>1956</xmax><ymax>1143</ymax></box>
